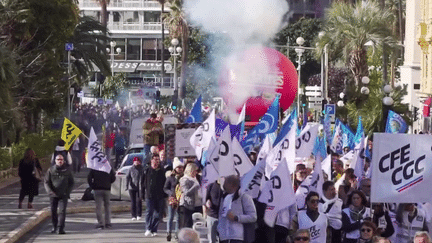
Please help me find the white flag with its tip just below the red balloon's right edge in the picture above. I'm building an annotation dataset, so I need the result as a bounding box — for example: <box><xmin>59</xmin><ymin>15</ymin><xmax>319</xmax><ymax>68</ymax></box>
<box><xmin>265</xmin><ymin>122</ymin><xmax>297</xmax><ymax>177</ymax></box>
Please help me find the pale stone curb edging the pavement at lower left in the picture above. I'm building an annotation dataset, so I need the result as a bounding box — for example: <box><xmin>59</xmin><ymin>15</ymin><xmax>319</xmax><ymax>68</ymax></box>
<box><xmin>0</xmin><ymin>205</ymin><xmax>130</xmax><ymax>243</ymax></box>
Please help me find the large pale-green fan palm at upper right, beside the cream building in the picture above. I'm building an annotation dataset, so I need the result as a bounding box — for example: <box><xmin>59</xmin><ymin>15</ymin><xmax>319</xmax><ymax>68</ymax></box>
<box><xmin>318</xmin><ymin>1</ymin><xmax>394</xmax><ymax>92</ymax></box>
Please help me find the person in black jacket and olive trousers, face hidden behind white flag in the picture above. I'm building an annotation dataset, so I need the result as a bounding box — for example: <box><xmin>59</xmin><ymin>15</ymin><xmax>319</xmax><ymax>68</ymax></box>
<box><xmin>87</xmin><ymin>169</ymin><xmax>116</xmax><ymax>229</ymax></box>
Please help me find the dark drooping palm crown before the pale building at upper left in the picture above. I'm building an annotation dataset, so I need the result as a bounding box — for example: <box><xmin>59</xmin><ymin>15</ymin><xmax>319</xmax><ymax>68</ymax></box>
<box><xmin>70</xmin><ymin>17</ymin><xmax>111</xmax><ymax>81</ymax></box>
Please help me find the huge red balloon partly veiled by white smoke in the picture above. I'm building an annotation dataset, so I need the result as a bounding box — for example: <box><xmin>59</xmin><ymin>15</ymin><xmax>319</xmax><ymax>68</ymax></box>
<box><xmin>219</xmin><ymin>47</ymin><xmax>298</xmax><ymax>121</ymax></box>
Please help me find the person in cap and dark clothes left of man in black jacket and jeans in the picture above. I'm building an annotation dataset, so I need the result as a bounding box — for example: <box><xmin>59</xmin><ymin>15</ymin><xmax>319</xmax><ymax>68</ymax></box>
<box><xmin>126</xmin><ymin>157</ymin><xmax>144</xmax><ymax>220</ymax></box>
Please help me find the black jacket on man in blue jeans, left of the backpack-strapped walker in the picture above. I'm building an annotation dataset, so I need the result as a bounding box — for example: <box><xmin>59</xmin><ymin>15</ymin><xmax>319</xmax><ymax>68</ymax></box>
<box><xmin>142</xmin><ymin>166</ymin><xmax>166</xmax><ymax>200</ymax></box>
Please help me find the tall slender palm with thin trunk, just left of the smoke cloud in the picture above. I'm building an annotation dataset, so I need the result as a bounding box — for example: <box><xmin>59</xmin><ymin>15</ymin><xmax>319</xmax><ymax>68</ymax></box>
<box><xmin>164</xmin><ymin>0</ymin><xmax>189</xmax><ymax>99</ymax></box>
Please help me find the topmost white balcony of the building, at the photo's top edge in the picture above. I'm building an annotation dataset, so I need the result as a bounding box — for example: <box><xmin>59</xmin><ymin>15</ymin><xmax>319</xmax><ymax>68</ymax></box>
<box><xmin>79</xmin><ymin>0</ymin><xmax>164</xmax><ymax>11</ymax></box>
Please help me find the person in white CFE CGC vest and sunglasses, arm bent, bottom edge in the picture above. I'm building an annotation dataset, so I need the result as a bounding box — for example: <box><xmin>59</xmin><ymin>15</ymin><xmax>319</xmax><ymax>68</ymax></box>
<box><xmin>292</xmin><ymin>191</ymin><xmax>328</xmax><ymax>243</ymax></box>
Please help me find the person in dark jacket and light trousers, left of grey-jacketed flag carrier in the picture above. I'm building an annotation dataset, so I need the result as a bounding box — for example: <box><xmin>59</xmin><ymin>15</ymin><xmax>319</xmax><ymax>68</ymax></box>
<box><xmin>205</xmin><ymin>180</ymin><xmax>222</xmax><ymax>243</ymax></box>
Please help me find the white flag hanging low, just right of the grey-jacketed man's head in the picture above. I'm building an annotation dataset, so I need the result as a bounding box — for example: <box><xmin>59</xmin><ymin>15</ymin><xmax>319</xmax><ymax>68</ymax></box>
<box><xmin>258</xmin><ymin>158</ymin><xmax>295</xmax><ymax>227</ymax></box>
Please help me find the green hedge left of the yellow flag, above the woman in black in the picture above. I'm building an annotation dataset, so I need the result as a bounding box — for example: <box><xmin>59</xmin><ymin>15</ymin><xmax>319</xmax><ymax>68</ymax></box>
<box><xmin>12</xmin><ymin>130</ymin><xmax>61</xmax><ymax>167</ymax></box>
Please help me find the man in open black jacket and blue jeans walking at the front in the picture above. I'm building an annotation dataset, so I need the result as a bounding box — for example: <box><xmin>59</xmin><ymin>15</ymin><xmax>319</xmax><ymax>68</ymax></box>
<box><xmin>142</xmin><ymin>154</ymin><xmax>166</xmax><ymax>237</ymax></box>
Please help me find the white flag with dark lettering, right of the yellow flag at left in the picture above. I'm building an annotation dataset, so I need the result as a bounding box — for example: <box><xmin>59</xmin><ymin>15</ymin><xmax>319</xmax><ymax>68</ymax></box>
<box><xmin>87</xmin><ymin>127</ymin><xmax>111</xmax><ymax>173</ymax></box>
